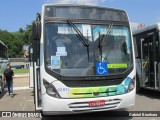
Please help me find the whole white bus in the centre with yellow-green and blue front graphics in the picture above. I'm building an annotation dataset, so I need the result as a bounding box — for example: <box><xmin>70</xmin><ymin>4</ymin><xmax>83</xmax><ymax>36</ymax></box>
<box><xmin>32</xmin><ymin>4</ymin><xmax>136</xmax><ymax>115</ymax></box>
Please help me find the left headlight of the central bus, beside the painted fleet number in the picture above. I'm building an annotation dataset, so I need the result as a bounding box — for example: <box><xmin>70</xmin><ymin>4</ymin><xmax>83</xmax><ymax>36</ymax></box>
<box><xmin>43</xmin><ymin>79</ymin><xmax>60</xmax><ymax>98</ymax></box>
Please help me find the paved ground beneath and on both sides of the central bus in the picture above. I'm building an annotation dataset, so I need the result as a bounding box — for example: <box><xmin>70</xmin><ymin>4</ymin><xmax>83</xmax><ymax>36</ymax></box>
<box><xmin>0</xmin><ymin>78</ymin><xmax>160</xmax><ymax>120</ymax></box>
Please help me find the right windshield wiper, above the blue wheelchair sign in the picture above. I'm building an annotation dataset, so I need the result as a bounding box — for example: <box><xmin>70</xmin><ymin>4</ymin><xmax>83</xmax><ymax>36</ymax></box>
<box><xmin>98</xmin><ymin>22</ymin><xmax>113</xmax><ymax>62</ymax></box>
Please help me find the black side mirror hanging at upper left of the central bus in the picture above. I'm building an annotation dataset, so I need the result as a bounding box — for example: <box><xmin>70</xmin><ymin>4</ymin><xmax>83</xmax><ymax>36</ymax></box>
<box><xmin>32</xmin><ymin>13</ymin><xmax>41</xmax><ymax>40</ymax></box>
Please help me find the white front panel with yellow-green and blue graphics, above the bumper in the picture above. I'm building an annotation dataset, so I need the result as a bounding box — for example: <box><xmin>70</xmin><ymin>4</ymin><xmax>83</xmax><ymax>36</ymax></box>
<box><xmin>41</xmin><ymin>66</ymin><xmax>136</xmax><ymax>99</ymax></box>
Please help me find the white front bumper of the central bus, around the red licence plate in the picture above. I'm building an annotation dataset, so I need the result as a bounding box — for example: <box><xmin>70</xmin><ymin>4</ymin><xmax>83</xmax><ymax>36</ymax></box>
<box><xmin>42</xmin><ymin>89</ymin><xmax>135</xmax><ymax>115</ymax></box>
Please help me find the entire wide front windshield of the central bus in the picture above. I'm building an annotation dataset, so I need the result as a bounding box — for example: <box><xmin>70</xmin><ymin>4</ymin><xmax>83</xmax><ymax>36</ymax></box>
<box><xmin>44</xmin><ymin>23</ymin><xmax>133</xmax><ymax>76</ymax></box>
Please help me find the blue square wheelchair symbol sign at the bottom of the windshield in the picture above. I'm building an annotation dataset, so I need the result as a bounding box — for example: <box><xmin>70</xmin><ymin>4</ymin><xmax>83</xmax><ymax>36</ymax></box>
<box><xmin>96</xmin><ymin>62</ymin><xmax>108</xmax><ymax>75</ymax></box>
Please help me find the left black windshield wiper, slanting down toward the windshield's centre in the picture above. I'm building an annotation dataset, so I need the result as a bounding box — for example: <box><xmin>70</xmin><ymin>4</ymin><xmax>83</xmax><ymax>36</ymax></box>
<box><xmin>67</xmin><ymin>20</ymin><xmax>89</xmax><ymax>61</ymax></box>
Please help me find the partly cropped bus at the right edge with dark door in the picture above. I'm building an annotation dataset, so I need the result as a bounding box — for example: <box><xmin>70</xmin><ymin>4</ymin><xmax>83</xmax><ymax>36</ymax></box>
<box><xmin>133</xmin><ymin>23</ymin><xmax>160</xmax><ymax>92</ymax></box>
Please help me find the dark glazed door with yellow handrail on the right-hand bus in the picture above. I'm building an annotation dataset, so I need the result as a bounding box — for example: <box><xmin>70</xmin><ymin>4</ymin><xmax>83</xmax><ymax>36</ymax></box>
<box><xmin>141</xmin><ymin>36</ymin><xmax>158</xmax><ymax>89</ymax></box>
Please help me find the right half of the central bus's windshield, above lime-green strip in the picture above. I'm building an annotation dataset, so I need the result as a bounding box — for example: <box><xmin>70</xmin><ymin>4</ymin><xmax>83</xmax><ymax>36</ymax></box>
<box><xmin>93</xmin><ymin>25</ymin><xmax>132</xmax><ymax>74</ymax></box>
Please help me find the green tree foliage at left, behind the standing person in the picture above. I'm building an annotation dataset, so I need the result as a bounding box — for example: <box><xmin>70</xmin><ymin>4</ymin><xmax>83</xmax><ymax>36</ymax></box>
<box><xmin>0</xmin><ymin>24</ymin><xmax>32</xmax><ymax>58</ymax></box>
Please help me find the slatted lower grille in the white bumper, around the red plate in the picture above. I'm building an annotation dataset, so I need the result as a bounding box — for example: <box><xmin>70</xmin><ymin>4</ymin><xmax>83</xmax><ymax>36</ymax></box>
<box><xmin>68</xmin><ymin>99</ymin><xmax>122</xmax><ymax>112</ymax></box>
